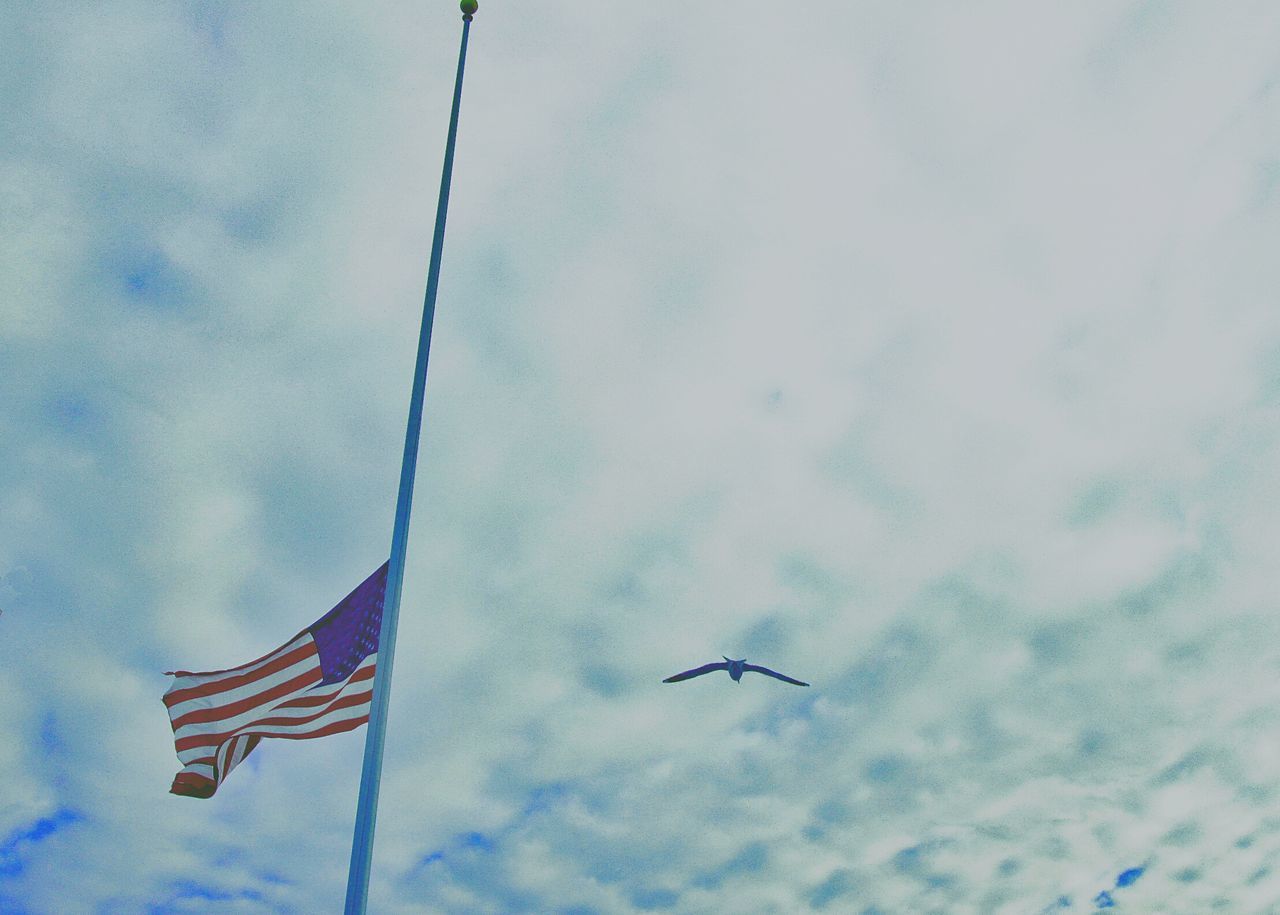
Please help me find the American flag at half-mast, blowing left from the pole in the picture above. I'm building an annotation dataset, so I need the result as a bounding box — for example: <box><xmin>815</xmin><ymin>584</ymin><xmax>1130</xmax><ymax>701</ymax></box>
<box><xmin>164</xmin><ymin>563</ymin><xmax>387</xmax><ymax>797</ymax></box>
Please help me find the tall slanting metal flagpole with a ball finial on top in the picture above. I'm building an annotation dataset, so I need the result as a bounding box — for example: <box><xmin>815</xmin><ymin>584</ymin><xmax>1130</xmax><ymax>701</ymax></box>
<box><xmin>344</xmin><ymin>0</ymin><xmax>479</xmax><ymax>915</ymax></box>
